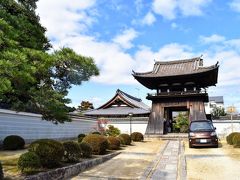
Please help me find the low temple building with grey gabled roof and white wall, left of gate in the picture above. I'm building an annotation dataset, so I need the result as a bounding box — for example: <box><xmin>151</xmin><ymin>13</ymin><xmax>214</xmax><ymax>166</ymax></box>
<box><xmin>84</xmin><ymin>89</ymin><xmax>150</xmax><ymax>134</ymax></box>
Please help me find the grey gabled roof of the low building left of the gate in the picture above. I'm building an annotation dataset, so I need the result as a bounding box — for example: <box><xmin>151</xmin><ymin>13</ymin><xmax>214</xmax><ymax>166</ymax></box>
<box><xmin>84</xmin><ymin>89</ymin><xmax>150</xmax><ymax>116</ymax></box>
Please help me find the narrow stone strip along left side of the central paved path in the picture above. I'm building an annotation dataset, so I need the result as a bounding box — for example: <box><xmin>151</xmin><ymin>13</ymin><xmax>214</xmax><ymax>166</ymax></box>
<box><xmin>140</xmin><ymin>141</ymin><xmax>169</xmax><ymax>180</ymax></box>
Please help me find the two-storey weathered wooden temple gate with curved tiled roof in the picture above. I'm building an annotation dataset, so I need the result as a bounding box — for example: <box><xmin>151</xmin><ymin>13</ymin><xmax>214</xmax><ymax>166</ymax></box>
<box><xmin>133</xmin><ymin>57</ymin><xmax>219</xmax><ymax>134</ymax></box>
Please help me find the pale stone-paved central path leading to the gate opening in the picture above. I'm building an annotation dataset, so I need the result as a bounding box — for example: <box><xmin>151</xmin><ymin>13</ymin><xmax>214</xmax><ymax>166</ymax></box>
<box><xmin>147</xmin><ymin>140</ymin><xmax>180</xmax><ymax>180</ymax></box>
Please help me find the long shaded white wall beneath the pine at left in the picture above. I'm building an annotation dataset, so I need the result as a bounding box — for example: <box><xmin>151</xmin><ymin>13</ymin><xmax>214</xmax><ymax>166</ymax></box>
<box><xmin>0</xmin><ymin>109</ymin><xmax>96</xmax><ymax>142</ymax></box>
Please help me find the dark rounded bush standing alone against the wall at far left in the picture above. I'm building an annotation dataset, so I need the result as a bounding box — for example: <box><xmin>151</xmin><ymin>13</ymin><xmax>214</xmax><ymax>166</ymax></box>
<box><xmin>3</xmin><ymin>135</ymin><xmax>25</xmax><ymax>150</ymax></box>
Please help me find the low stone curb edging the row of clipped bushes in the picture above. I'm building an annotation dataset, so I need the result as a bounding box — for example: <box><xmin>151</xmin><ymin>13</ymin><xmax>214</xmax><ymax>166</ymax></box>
<box><xmin>24</xmin><ymin>152</ymin><xmax>121</xmax><ymax>180</ymax></box>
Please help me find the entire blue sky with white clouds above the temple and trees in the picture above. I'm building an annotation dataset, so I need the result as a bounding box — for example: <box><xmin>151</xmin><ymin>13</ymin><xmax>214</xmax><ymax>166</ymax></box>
<box><xmin>37</xmin><ymin>0</ymin><xmax>240</xmax><ymax>110</ymax></box>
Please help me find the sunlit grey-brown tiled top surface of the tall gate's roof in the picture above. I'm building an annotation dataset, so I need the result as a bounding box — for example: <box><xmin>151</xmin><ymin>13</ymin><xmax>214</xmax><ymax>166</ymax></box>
<box><xmin>133</xmin><ymin>57</ymin><xmax>218</xmax><ymax>77</ymax></box>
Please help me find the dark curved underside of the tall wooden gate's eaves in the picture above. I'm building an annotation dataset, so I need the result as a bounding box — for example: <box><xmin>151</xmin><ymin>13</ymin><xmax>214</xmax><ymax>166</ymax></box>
<box><xmin>133</xmin><ymin>65</ymin><xmax>219</xmax><ymax>89</ymax></box>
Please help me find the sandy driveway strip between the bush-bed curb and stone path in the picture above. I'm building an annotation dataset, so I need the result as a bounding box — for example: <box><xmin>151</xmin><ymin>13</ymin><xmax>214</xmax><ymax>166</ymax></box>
<box><xmin>72</xmin><ymin>140</ymin><xmax>166</xmax><ymax>180</ymax></box>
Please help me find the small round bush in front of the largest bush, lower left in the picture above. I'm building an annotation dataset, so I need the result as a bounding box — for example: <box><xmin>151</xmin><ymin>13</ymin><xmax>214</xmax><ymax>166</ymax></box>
<box><xmin>17</xmin><ymin>152</ymin><xmax>41</xmax><ymax>172</ymax></box>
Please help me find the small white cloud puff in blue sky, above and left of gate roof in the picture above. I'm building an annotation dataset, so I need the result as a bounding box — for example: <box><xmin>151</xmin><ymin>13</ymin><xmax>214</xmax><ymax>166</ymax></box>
<box><xmin>113</xmin><ymin>28</ymin><xmax>139</xmax><ymax>49</ymax></box>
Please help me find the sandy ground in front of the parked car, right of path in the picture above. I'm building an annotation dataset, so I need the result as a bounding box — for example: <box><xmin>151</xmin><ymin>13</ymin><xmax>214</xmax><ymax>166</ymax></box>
<box><xmin>185</xmin><ymin>142</ymin><xmax>240</xmax><ymax>180</ymax></box>
